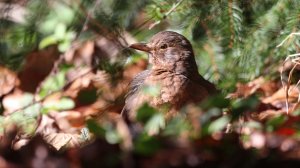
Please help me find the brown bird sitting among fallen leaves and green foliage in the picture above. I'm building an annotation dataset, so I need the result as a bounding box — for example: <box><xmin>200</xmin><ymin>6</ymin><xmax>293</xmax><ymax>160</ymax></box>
<box><xmin>121</xmin><ymin>31</ymin><xmax>216</xmax><ymax>120</ymax></box>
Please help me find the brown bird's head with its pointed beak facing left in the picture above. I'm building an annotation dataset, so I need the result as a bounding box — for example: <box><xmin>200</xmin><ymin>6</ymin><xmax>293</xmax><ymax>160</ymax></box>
<box><xmin>129</xmin><ymin>31</ymin><xmax>197</xmax><ymax>73</ymax></box>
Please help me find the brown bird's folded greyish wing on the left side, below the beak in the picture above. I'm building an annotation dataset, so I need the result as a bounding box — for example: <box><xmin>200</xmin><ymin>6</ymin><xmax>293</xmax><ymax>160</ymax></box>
<box><xmin>121</xmin><ymin>70</ymin><xmax>150</xmax><ymax>119</ymax></box>
